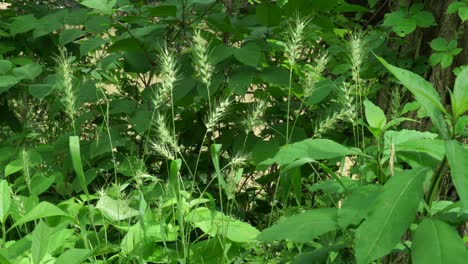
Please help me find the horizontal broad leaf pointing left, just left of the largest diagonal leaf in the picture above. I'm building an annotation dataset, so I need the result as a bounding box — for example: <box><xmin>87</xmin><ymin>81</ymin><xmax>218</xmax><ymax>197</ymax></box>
<box><xmin>257</xmin><ymin>208</ymin><xmax>339</xmax><ymax>243</ymax></box>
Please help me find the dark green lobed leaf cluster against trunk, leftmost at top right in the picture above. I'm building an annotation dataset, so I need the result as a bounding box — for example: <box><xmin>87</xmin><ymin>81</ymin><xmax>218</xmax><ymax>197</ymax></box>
<box><xmin>383</xmin><ymin>3</ymin><xmax>435</xmax><ymax>37</ymax></box>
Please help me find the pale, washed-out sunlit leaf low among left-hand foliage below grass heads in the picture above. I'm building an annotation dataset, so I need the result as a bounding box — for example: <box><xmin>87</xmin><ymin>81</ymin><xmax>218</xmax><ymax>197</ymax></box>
<box><xmin>96</xmin><ymin>195</ymin><xmax>139</xmax><ymax>221</ymax></box>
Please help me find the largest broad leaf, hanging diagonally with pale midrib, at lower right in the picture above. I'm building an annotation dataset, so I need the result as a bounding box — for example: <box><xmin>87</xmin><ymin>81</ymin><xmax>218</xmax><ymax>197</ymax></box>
<box><xmin>355</xmin><ymin>168</ymin><xmax>428</xmax><ymax>264</ymax></box>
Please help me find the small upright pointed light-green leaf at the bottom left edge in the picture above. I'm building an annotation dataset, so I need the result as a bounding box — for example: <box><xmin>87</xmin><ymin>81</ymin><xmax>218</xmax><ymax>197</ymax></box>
<box><xmin>31</xmin><ymin>220</ymin><xmax>52</xmax><ymax>264</ymax></box>
